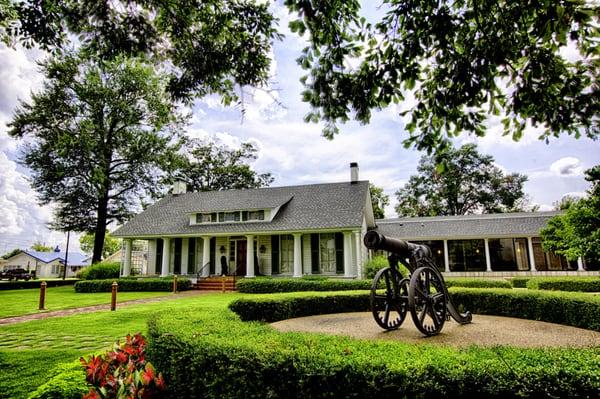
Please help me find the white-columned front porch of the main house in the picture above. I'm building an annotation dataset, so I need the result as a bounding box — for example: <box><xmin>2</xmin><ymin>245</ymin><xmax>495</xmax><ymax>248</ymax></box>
<box><xmin>121</xmin><ymin>230</ymin><xmax>367</xmax><ymax>278</ymax></box>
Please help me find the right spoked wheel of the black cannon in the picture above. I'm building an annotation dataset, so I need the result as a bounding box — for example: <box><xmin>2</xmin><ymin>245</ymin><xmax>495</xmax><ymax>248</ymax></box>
<box><xmin>408</xmin><ymin>266</ymin><xmax>447</xmax><ymax>336</ymax></box>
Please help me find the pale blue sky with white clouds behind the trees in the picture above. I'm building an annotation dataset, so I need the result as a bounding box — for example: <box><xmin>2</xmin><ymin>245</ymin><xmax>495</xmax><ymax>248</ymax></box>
<box><xmin>0</xmin><ymin>2</ymin><xmax>600</xmax><ymax>253</ymax></box>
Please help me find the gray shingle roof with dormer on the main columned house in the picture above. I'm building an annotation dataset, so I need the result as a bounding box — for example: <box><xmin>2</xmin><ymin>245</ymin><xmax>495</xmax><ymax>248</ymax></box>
<box><xmin>112</xmin><ymin>181</ymin><xmax>369</xmax><ymax>237</ymax></box>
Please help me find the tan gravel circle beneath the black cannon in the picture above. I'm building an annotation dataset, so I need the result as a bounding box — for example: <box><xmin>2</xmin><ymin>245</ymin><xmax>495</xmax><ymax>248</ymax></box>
<box><xmin>271</xmin><ymin>312</ymin><xmax>600</xmax><ymax>348</ymax></box>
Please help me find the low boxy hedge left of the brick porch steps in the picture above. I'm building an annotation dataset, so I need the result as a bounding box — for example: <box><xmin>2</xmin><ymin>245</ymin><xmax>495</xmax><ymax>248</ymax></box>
<box><xmin>75</xmin><ymin>278</ymin><xmax>192</xmax><ymax>293</ymax></box>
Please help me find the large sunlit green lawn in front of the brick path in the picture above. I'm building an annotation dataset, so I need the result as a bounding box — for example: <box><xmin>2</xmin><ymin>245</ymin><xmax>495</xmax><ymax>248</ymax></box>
<box><xmin>0</xmin><ymin>287</ymin><xmax>241</xmax><ymax>399</ymax></box>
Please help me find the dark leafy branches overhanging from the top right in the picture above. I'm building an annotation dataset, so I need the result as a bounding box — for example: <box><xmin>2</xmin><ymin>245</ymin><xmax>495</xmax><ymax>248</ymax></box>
<box><xmin>285</xmin><ymin>0</ymin><xmax>600</xmax><ymax>151</ymax></box>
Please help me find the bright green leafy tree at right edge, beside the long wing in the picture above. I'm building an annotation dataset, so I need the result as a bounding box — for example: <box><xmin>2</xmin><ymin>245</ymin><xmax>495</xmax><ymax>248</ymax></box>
<box><xmin>540</xmin><ymin>165</ymin><xmax>600</xmax><ymax>269</ymax></box>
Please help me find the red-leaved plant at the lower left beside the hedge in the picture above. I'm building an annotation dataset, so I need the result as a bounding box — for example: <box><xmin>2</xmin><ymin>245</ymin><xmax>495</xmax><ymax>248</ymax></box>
<box><xmin>79</xmin><ymin>334</ymin><xmax>165</xmax><ymax>399</ymax></box>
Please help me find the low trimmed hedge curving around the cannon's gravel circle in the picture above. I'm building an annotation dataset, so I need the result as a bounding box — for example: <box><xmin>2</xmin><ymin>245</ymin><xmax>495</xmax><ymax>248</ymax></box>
<box><xmin>148</xmin><ymin>289</ymin><xmax>600</xmax><ymax>399</ymax></box>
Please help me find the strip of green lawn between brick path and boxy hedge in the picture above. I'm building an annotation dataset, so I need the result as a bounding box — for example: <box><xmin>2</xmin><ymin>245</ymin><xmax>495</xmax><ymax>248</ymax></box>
<box><xmin>0</xmin><ymin>286</ymin><xmax>170</xmax><ymax>318</ymax></box>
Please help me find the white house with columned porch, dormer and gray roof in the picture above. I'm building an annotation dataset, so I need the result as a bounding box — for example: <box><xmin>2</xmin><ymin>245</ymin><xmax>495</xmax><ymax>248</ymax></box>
<box><xmin>113</xmin><ymin>163</ymin><xmax>375</xmax><ymax>277</ymax></box>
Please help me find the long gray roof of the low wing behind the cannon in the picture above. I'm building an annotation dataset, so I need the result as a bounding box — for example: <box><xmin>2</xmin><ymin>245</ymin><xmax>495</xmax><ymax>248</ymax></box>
<box><xmin>376</xmin><ymin>212</ymin><xmax>559</xmax><ymax>240</ymax></box>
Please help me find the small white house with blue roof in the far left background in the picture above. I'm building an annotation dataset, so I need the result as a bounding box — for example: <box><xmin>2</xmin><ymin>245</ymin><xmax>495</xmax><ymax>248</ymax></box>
<box><xmin>2</xmin><ymin>250</ymin><xmax>90</xmax><ymax>278</ymax></box>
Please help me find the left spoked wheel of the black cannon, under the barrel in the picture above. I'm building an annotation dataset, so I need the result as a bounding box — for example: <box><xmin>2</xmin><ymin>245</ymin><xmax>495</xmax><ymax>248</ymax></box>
<box><xmin>371</xmin><ymin>267</ymin><xmax>409</xmax><ymax>330</ymax></box>
